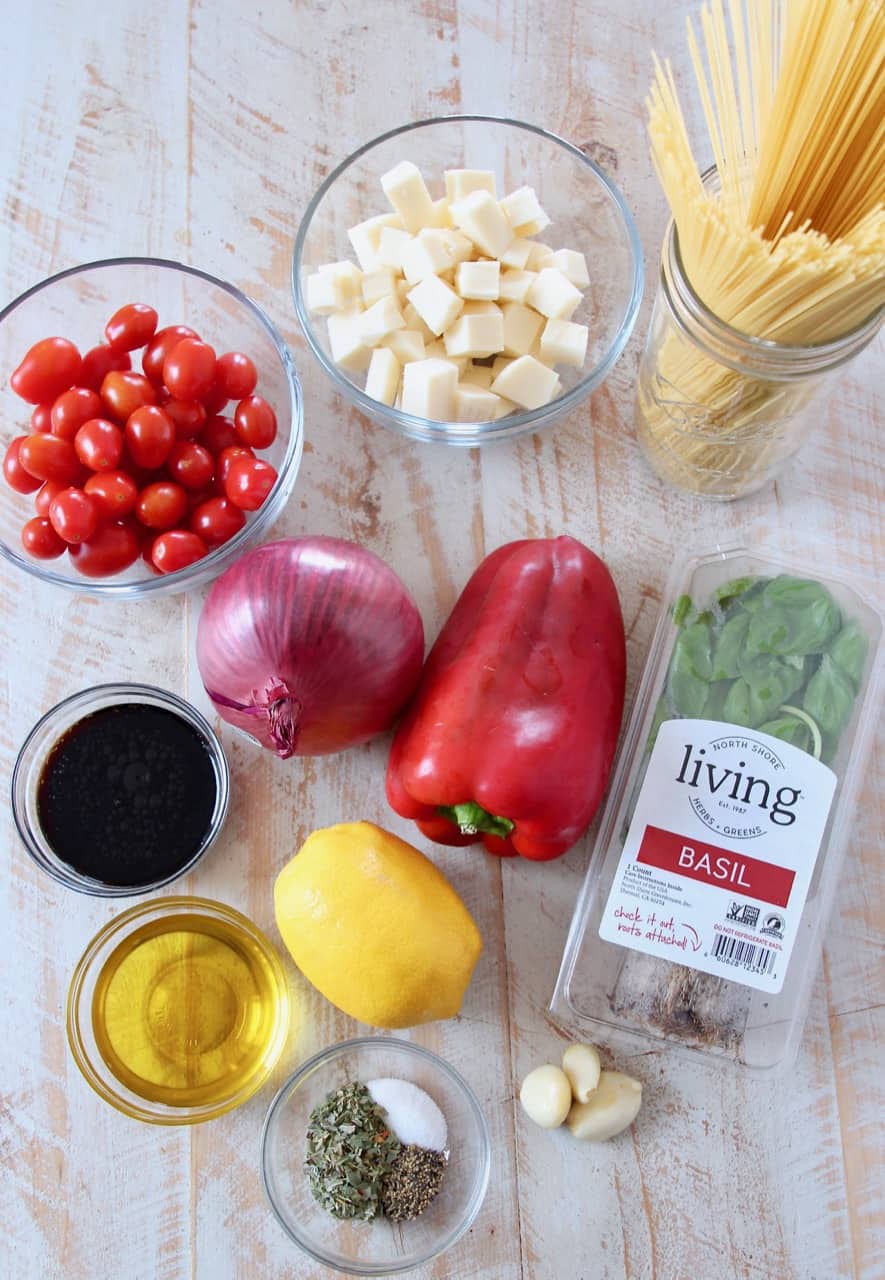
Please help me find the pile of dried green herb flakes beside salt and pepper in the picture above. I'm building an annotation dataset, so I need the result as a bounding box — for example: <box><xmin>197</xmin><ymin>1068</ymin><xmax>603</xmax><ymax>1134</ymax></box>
<box><xmin>305</xmin><ymin>1083</ymin><xmax>402</xmax><ymax>1222</ymax></box>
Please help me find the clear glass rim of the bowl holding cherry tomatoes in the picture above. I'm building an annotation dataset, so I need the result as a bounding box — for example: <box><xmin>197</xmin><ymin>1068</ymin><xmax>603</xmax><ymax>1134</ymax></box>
<box><xmin>0</xmin><ymin>256</ymin><xmax>304</xmax><ymax>600</ymax></box>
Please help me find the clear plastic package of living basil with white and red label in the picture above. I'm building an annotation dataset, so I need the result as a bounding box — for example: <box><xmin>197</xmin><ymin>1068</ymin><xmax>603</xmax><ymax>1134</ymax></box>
<box><xmin>551</xmin><ymin>548</ymin><xmax>884</xmax><ymax>1071</ymax></box>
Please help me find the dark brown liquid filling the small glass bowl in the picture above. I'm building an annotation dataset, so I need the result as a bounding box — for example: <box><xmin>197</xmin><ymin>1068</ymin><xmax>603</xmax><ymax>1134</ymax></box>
<box><xmin>37</xmin><ymin>703</ymin><xmax>218</xmax><ymax>886</ymax></box>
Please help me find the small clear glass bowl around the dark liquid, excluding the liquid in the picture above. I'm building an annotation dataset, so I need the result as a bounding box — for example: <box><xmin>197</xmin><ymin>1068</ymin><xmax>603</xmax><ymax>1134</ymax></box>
<box><xmin>12</xmin><ymin>685</ymin><xmax>231</xmax><ymax>897</ymax></box>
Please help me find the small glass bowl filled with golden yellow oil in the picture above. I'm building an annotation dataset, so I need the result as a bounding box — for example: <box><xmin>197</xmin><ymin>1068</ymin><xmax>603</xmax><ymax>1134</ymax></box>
<box><xmin>67</xmin><ymin>897</ymin><xmax>289</xmax><ymax>1125</ymax></box>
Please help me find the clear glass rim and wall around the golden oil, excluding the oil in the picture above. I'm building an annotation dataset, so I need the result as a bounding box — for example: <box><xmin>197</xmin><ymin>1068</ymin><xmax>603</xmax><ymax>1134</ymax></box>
<box><xmin>67</xmin><ymin>897</ymin><xmax>289</xmax><ymax>1125</ymax></box>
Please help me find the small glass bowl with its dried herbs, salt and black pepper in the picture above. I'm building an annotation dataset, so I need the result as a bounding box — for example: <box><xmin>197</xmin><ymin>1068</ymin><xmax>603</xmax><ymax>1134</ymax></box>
<box><xmin>261</xmin><ymin>1037</ymin><xmax>491</xmax><ymax>1276</ymax></box>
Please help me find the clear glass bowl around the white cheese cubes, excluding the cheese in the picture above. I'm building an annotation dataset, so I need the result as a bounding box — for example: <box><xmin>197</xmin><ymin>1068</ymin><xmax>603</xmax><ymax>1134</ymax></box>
<box><xmin>292</xmin><ymin>115</ymin><xmax>643</xmax><ymax>445</ymax></box>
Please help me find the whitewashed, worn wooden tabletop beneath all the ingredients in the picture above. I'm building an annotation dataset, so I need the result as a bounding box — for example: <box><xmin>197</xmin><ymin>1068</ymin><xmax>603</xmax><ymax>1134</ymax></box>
<box><xmin>0</xmin><ymin>0</ymin><xmax>885</xmax><ymax>1280</ymax></box>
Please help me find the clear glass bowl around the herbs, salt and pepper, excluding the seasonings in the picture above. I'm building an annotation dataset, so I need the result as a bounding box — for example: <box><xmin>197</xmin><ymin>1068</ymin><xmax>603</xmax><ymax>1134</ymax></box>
<box><xmin>261</xmin><ymin>1036</ymin><xmax>491</xmax><ymax>1276</ymax></box>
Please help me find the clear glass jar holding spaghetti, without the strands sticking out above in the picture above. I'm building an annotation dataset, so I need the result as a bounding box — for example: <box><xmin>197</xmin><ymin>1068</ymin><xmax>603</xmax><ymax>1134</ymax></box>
<box><xmin>637</xmin><ymin>170</ymin><xmax>885</xmax><ymax>502</ymax></box>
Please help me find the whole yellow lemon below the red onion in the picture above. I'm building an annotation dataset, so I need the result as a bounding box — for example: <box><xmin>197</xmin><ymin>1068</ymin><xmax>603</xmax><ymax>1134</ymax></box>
<box><xmin>274</xmin><ymin>822</ymin><xmax>483</xmax><ymax>1028</ymax></box>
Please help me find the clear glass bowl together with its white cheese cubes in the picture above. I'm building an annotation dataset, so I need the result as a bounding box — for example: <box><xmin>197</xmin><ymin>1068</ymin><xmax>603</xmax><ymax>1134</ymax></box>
<box><xmin>292</xmin><ymin>115</ymin><xmax>643</xmax><ymax>445</ymax></box>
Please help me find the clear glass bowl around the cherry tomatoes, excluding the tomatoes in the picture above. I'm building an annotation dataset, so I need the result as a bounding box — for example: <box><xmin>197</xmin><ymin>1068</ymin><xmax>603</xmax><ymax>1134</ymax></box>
<box><xmin>0</xmin><ymin>257</ymin><xmax>304</xmax><ymax>600</ymax></box>
